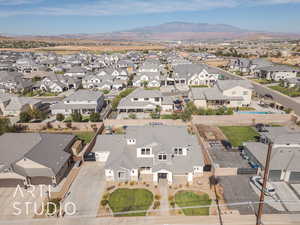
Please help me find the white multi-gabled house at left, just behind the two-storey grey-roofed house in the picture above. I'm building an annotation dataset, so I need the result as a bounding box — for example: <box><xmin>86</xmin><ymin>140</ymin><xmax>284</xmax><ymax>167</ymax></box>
<box><xmin>40</xmin><ymin>73</ymin><xmax>81</xmax><ymax>93</ymax></box>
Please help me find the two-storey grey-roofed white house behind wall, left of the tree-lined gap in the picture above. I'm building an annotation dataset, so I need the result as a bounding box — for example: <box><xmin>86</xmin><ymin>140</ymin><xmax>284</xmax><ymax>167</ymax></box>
<box><xmin>51</xmin><ymin>90</ymin><xmax>104</xmax><ymax>115</ymax></box>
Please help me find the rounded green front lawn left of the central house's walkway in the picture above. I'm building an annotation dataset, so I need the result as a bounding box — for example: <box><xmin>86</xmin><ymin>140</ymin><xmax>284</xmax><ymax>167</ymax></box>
<box><xmin>108</xmin><ymin>188</ymin><xmax>153</xmax><ymax>216</ymax></box>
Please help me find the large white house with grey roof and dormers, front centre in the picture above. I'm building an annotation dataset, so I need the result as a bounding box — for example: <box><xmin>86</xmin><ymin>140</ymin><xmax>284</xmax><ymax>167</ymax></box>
<box><xmin>93</xmin><ymin>125</ymin><xmax>204</xmax><ymax>185</ymax></box>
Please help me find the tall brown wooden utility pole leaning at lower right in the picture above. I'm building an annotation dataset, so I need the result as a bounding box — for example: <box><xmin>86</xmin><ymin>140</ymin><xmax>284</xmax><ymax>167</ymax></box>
<box><xmin>256</xmin><ymin>142</ymin><xmax>273</xmax><ymax>225</ymax></box>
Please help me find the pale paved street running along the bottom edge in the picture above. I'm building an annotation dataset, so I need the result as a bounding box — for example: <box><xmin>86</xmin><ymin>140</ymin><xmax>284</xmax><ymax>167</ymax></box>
<box><xmin>0</xmin><ymin>215</ymin><xmax>300</xmax><ymax>225</ymax></box>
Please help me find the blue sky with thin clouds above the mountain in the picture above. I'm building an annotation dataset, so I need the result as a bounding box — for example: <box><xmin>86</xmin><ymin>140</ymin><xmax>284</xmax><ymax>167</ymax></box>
<box><xmin>0</xmin><ymin>0</ymin><xmax>300</xmax><ymax>35</ymax></box>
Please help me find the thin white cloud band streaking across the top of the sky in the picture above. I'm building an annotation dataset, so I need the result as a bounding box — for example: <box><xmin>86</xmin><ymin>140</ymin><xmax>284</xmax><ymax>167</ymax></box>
<box><xmin>0</xmin><ymin>0</ymin><xmax>300</xmax><ymax>16</ymax></box>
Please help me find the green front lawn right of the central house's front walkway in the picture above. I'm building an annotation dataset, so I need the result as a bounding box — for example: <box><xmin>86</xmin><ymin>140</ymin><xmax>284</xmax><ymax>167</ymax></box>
<box><xmin>175</xmin><ymin>191</ymin><xmax>211</xmax><ymax>216</ymax></box>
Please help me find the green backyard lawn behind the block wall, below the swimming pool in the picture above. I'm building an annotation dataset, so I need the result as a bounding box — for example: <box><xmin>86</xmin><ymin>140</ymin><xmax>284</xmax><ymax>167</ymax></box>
<box><xmin>219</xmin><ymin>126</ymin><xmax>259</xmax><ymax>147</ymax></box>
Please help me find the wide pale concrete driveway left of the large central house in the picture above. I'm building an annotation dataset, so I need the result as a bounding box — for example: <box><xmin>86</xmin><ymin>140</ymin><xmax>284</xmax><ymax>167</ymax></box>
<box><xmin>63</xmin><ymin>162</ymin><xmax>105</xmax><ymax>216</ymax></box>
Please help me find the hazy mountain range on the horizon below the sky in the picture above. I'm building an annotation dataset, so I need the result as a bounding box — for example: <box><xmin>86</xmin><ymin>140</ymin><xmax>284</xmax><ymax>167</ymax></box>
<box><xmin>2</xmin><ymin>22</ymin><xmax>300</xmax><ymax>41</ymax></box>
